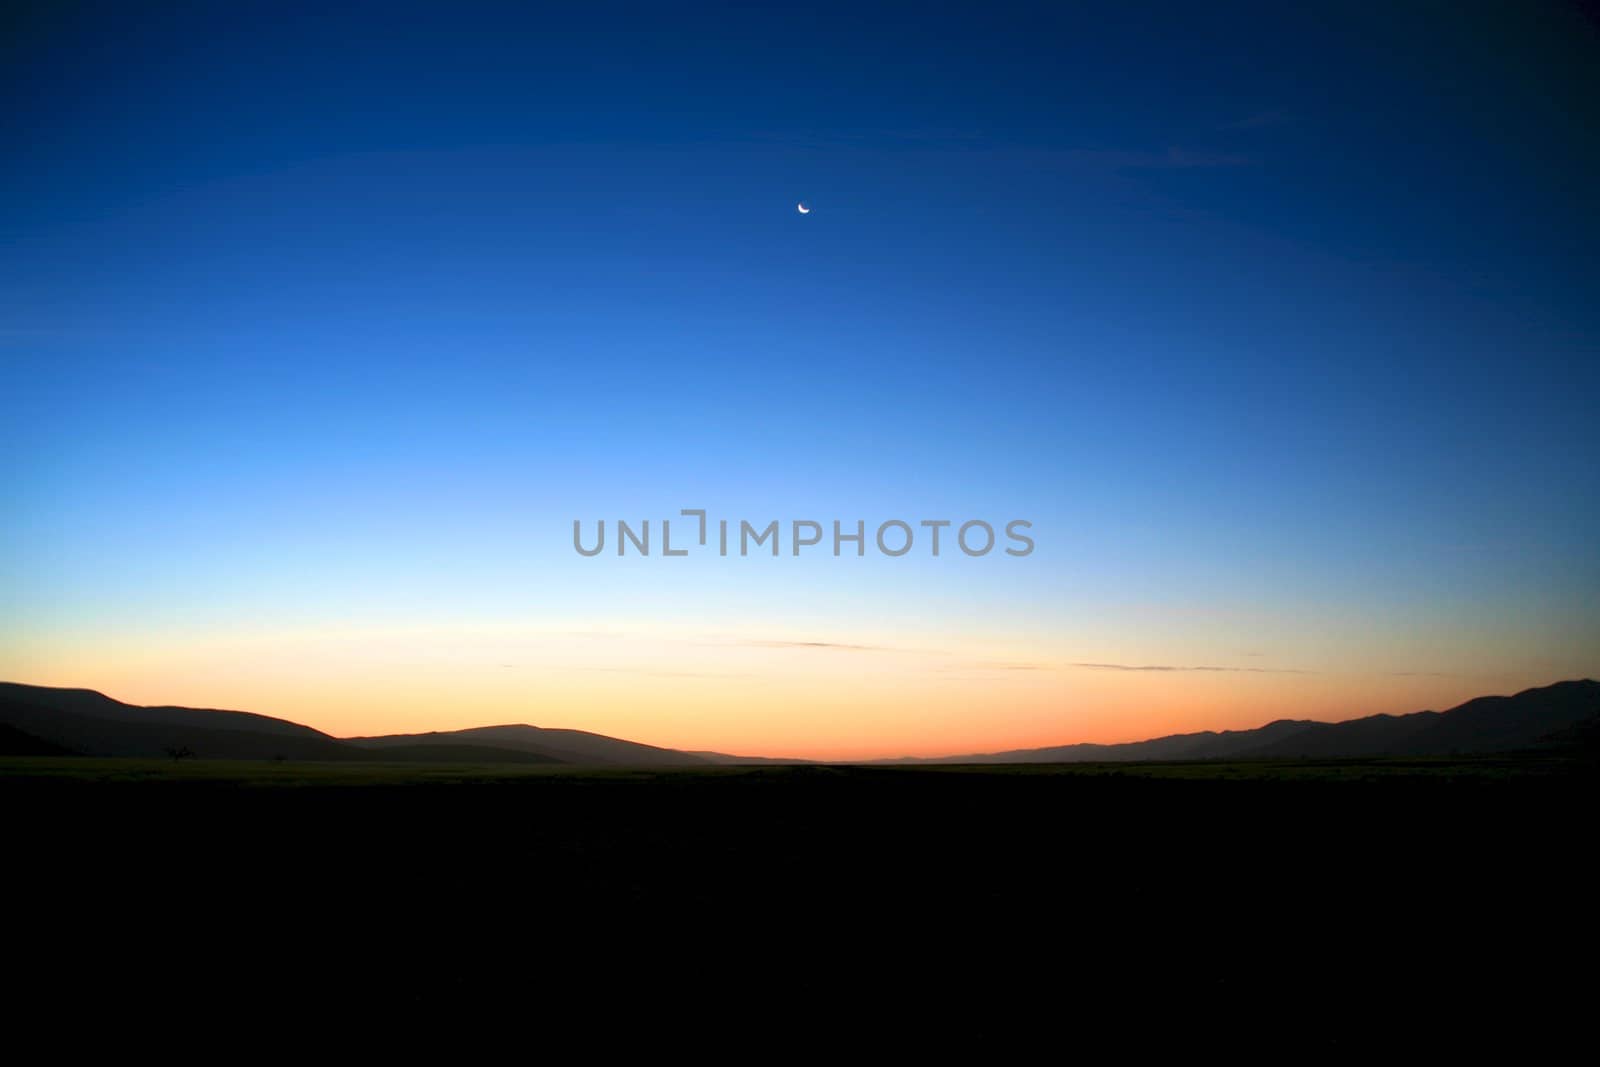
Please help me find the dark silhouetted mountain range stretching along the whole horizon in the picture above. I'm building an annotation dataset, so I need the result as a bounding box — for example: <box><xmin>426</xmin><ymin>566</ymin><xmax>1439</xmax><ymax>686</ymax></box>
<box><xmin>0</xmin><ymin>678</ymin><xmax>1600</xmax><ymax>766</ymax></box>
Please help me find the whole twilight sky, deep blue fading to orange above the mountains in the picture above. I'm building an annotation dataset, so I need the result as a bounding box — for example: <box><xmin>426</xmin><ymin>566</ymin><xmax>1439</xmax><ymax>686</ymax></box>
<box><xmin>0</xmin><ymin>3</ymin><xmax>1600</xmax><ymax>758</ymax></box>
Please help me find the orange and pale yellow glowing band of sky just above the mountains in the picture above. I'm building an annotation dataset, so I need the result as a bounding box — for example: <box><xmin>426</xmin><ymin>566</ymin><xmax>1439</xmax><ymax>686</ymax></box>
<box><xmin>0</xmin><ymin>627</ymin><xmax>1571</xmax><ymax>760</ymax></box>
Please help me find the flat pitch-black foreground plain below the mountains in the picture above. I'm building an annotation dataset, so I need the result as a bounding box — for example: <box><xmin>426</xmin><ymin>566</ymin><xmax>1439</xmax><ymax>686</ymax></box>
<box><xmin>0</xmin><ymin>758</ymin><xmax>1597</xmax><ymax>1053</ymax></box>
